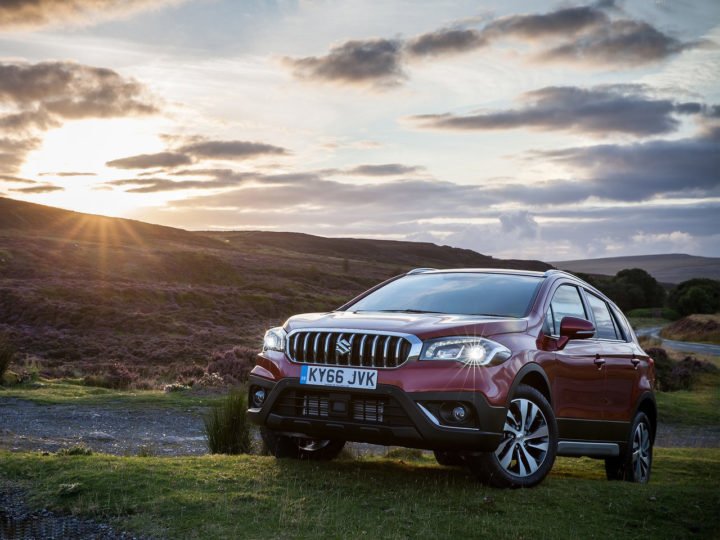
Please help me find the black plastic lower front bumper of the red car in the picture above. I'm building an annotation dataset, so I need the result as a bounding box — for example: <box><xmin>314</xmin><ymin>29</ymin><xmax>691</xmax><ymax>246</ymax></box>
<box><xmin>248</xmin><ymin>375</ymin><xmax>506</xmax><ymax>451</ymax></box>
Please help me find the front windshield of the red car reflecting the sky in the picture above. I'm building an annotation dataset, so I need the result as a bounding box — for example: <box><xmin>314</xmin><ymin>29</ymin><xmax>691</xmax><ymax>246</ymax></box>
<box><xmin>347</xmin><ymin>272</ymin><xmax>543</xmax><ymax>317</ymax></box>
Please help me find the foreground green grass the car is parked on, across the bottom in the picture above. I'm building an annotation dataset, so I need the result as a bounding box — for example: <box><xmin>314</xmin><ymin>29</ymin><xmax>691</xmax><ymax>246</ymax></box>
<box><xmin>0</xmin><ymin>449</ymin><xmax>720</xmax><ymax>539</ymax></box>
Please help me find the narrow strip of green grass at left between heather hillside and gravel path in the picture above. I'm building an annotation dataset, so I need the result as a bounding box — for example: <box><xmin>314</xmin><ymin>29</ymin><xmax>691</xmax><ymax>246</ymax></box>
<box><xmin>0</xmin><ymin>379</ymin><xmax>222</xmax><ymax>407</ymax></box>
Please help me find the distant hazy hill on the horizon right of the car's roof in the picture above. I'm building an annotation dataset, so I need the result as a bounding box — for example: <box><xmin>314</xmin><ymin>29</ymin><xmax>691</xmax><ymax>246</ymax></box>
<box><xmin>550</xmin><ymin>253</ymin><xmax>720</xmax><ymax>283</ymax></box>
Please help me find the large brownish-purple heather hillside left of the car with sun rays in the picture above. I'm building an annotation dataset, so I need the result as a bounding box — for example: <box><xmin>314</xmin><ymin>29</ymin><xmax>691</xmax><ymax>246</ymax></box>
<box><xmin>0</xmin><ymin>198</ymin><xmax>549</xmax><ymax>381</ymax></box>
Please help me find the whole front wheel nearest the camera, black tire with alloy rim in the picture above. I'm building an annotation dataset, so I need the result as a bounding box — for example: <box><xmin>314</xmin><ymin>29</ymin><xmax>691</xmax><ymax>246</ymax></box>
<box><xmin>466</xmin><ymin>385</ymin><xmax>558</xmax><ymax>488</ymax></box>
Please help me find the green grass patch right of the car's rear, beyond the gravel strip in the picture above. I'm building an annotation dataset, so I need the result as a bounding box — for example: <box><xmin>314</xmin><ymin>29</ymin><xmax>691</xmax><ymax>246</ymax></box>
<box><xmin>655</xmin><ymin>373</ymin><xmax>720</xmax><ymax>426</ymax></box>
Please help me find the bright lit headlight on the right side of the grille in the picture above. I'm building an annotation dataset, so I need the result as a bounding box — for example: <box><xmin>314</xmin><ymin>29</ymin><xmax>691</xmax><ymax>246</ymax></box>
<box><xmin>420</xmin><ymin>336</ymin><xmax>511</xmax><ymax>366</ymax></box>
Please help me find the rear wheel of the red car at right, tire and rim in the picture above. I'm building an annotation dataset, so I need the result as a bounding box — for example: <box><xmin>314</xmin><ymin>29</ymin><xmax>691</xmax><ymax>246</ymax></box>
<box><xmin>605</xmin><ymin>412</ymin><xmax>653</xmax><ymax>484</ymax></box>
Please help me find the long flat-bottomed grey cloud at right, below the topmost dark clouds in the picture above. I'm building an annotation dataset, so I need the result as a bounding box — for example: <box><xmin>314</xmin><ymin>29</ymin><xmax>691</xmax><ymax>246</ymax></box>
<box><xmin>412</xmin><ymin>85</ymin><xmax>702</xmax><ymax>136</ymax></box>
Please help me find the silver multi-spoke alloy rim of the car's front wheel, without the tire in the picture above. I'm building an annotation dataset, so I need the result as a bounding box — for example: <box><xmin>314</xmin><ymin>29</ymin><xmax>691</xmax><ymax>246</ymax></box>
<box><xmin>495</xmin><ymin>398</ymin><xmax>550</xmax><ymax>477</ymax></box>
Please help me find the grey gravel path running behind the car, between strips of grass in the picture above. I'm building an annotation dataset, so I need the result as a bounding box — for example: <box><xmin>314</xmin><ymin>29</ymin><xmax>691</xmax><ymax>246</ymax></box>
<box><xmin>0</xmin><ymin>398</ymin><xmax>720</xmax><ymax>456</ymax></box>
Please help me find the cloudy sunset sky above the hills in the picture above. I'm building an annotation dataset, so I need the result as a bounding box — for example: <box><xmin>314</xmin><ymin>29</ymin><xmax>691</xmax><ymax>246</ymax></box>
<box><xmin>0</xmin><ymin>0</ymin><xmax>720</xmax><ymax>261</ymax></box>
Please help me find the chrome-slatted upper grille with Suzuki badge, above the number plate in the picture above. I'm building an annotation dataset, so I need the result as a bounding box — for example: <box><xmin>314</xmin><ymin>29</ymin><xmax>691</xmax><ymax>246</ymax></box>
<box><xmin>287</xmin><ymin>330</ymin><xmax>412</xmax><ymax>368</ymax></box>
